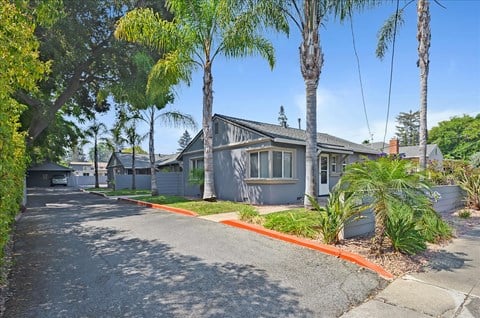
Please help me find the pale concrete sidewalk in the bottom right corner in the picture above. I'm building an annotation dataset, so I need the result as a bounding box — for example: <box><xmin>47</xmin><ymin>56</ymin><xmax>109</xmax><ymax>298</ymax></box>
<box><xmin>342</xmin><ymin>225</ymin><xmax>480</xmax><ymax>318</ymax></box>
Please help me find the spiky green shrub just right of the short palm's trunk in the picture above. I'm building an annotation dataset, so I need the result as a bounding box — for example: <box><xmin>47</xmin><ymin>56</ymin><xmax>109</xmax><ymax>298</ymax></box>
<box><xmin>385</xmin><ymin>204</ymin><xmax>427</xmax><ymax>255</ymax></box>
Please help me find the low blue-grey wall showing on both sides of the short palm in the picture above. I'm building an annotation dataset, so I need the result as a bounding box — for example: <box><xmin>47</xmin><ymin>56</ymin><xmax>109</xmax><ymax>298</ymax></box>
<box><xmin>343</xmin><ymin>185</ymin><xmax>465</xmax><ymax>238</ymax></box>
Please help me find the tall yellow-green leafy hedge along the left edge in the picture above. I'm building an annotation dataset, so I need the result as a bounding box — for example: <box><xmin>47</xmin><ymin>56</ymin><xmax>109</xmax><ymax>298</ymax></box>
<box><xmin>0</xmin><ymin>0</ymin><xmax>49</xmax><ymax>263</ymax></box>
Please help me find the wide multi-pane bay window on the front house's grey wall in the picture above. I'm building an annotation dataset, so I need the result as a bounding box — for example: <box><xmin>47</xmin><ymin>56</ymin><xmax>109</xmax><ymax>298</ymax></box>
<box><xmin>250</xmin><ymin>150</ymin><xmax>293</xmax><ymax>179</ymax></box>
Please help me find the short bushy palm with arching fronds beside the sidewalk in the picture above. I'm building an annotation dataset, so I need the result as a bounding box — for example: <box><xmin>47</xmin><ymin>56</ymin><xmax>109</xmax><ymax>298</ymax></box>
<box><xmin>338</xmin><ymin>158</ymin><xmax>430</xmax><ymax>254</ymax></box>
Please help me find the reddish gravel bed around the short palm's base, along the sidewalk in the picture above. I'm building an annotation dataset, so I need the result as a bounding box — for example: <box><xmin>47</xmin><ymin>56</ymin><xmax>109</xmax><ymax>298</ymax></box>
<box><xmin>337</xmin><ymin>209</ymin><xmax>480</xmax><ymax>277</ymax></box>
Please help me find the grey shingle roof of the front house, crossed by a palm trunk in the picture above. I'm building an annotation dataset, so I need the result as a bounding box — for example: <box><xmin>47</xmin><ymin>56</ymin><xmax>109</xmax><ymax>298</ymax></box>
<box><xmin>214</xmin><ymin>114</ymin><xmax>379</xmax><ymax>154</ymax></box>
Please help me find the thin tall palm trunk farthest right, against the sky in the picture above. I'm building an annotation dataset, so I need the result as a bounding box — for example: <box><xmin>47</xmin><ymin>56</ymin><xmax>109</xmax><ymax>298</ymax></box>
<box><xmin>417</xmin><ymin>0</ymin><xmax>431</xmax><ymax>170</ymax></box>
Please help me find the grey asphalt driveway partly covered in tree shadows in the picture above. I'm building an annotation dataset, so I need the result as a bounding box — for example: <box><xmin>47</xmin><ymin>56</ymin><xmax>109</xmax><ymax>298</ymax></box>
<box><xmin>4</xmin><ymin>188</ymin><xmax>385</xmax><ymax>318</ymax></box>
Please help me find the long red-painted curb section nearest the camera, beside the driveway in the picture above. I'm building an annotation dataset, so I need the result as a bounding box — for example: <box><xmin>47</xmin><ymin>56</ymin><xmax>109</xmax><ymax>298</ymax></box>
<box><xmin>220</xmin><ymin>220</ymin><xmax>394</xmax><ymax>280</ymax></box>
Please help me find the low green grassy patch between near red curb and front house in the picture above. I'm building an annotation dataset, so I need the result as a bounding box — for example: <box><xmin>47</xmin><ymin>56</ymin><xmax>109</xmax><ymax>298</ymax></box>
<box><xmin>263</xmin><ymin>209</ymin><xmax>319</xmax><ymax>239</ymax></box>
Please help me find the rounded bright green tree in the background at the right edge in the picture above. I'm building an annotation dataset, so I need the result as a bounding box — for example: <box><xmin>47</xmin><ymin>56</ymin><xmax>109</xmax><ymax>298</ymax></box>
<box><xmin>428</xmin><ymin>114</ymin><xmax>480</xmax><ymax>160</ymax></box>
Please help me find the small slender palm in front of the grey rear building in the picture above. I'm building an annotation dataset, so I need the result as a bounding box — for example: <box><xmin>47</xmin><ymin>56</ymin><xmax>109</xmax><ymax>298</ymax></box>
<box><xmin>139</xmin><ymin>105</ymin><xmax>196</xmax><ymax>196</ymax></box>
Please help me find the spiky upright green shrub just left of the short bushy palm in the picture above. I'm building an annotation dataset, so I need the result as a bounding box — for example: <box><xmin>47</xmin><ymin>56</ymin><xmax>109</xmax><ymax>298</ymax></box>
<box><xmin>307</xmin><ymin>188</ymin><xmax>361</xmax><ymax>244</ymax></box>
